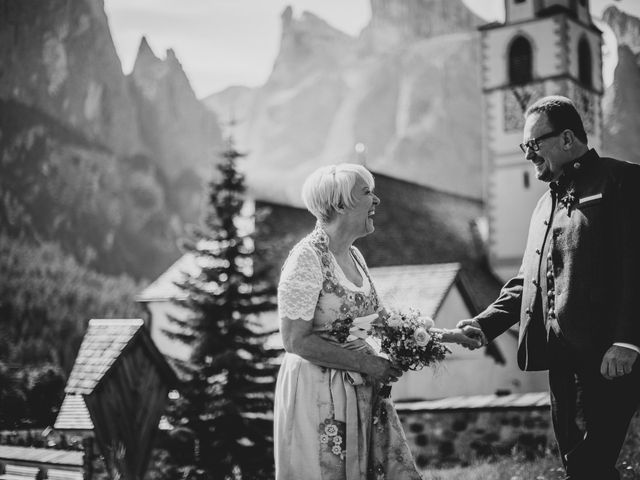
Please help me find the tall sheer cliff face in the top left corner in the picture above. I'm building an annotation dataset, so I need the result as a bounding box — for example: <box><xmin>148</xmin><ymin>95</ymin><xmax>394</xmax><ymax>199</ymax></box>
<box><xmin>0</xmin><ymin>0</ymin><xmax>142</xmax><ymax>155</ymax></box>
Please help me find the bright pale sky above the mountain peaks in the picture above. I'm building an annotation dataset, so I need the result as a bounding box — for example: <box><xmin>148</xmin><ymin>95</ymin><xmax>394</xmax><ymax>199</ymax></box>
<box><xmin>104</xmin><ymin>0</ymin><xmax>640</xmax><ymax>98</ymax></box>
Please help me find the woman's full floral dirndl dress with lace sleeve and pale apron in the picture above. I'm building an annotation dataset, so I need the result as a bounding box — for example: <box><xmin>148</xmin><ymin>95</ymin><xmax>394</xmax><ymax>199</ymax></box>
<box><xmin>274</xmin><ymin>226</ymin><xmax>421</xmax><ymax>480</ymax></box>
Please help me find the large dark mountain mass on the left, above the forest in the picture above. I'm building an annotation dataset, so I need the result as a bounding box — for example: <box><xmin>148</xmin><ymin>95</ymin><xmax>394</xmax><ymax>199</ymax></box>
<box><xmin>0</xmin><ymin>0</ymin><xmax>222</xmax><ymax>278</ymax></box>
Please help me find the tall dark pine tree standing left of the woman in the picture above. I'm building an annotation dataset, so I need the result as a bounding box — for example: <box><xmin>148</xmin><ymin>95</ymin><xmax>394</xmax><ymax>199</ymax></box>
<box><xmin>170</xmin><ymin>140</ymin><xmax>279</xmax><ymax>480</ymax></box>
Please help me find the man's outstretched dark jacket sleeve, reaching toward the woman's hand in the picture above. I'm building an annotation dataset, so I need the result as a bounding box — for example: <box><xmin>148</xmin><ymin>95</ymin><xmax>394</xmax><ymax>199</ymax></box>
<box><xmin>475</xmin><ymin>267</ymin><xmax>524</xmax><ymax>341</ymax></box>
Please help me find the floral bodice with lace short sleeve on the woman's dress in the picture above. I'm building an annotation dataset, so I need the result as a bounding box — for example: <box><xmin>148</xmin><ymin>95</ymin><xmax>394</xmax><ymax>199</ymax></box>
<box><xmin>278</xmin><ymin>227</ymin><xmax>378</xmax><ymax>330</ymax></box>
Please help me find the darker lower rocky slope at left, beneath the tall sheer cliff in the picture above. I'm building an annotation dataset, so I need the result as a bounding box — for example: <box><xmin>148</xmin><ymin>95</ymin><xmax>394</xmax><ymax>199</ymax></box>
<box><xmin>0</xmin><ymin>100</ymin><xmax>178</xmax><ymax>278</ymax></box>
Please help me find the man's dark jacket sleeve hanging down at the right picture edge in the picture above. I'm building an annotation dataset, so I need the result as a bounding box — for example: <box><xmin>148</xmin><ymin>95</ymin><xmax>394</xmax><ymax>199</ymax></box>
<box><xmin>613</xmin><ymin>164</ymin><xmax>640</xmax><ymax>347</ymax></box>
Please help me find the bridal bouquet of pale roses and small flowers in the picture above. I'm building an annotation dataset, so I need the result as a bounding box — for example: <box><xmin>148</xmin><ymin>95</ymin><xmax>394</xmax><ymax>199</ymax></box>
<box><xmin>369</xmin><ymin>309</ymin><xmax>451</xmax><ymax>395</ymax></box>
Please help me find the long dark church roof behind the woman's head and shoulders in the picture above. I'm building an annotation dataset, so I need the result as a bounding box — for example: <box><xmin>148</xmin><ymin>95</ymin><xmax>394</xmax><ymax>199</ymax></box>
<box><xmin>256</xmin><ymin>174</ymin><xmax>488</xmax><ymax>280</ymax></box>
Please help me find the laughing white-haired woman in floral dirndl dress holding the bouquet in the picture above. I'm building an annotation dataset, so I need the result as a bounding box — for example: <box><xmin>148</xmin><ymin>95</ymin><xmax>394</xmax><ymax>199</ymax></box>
<box><xmin>274</xmin><ymin>164</ymin><xmax>470</xmax><ymax>480</ymax></box>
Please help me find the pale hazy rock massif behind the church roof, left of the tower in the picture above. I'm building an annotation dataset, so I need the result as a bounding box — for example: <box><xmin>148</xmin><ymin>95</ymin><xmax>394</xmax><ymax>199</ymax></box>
<box><xmin>212</xmin><ymin>0</ymin><xmax>482</xmax><ymax>204</ymax></box>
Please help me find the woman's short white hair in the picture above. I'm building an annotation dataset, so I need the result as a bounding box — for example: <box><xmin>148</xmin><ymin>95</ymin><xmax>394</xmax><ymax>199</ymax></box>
<box><xmin>302</xmin><ymin>163</ymin><xmax>375</xmax><ymax>223</ymax></box>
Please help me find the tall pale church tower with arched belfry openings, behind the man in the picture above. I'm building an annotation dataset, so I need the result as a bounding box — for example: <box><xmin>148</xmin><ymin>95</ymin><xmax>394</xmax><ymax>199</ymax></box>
<box><xmin>480</xmin><ymin>0</ymin><xmax>603</xmax><ymax>279</ymax></box>
